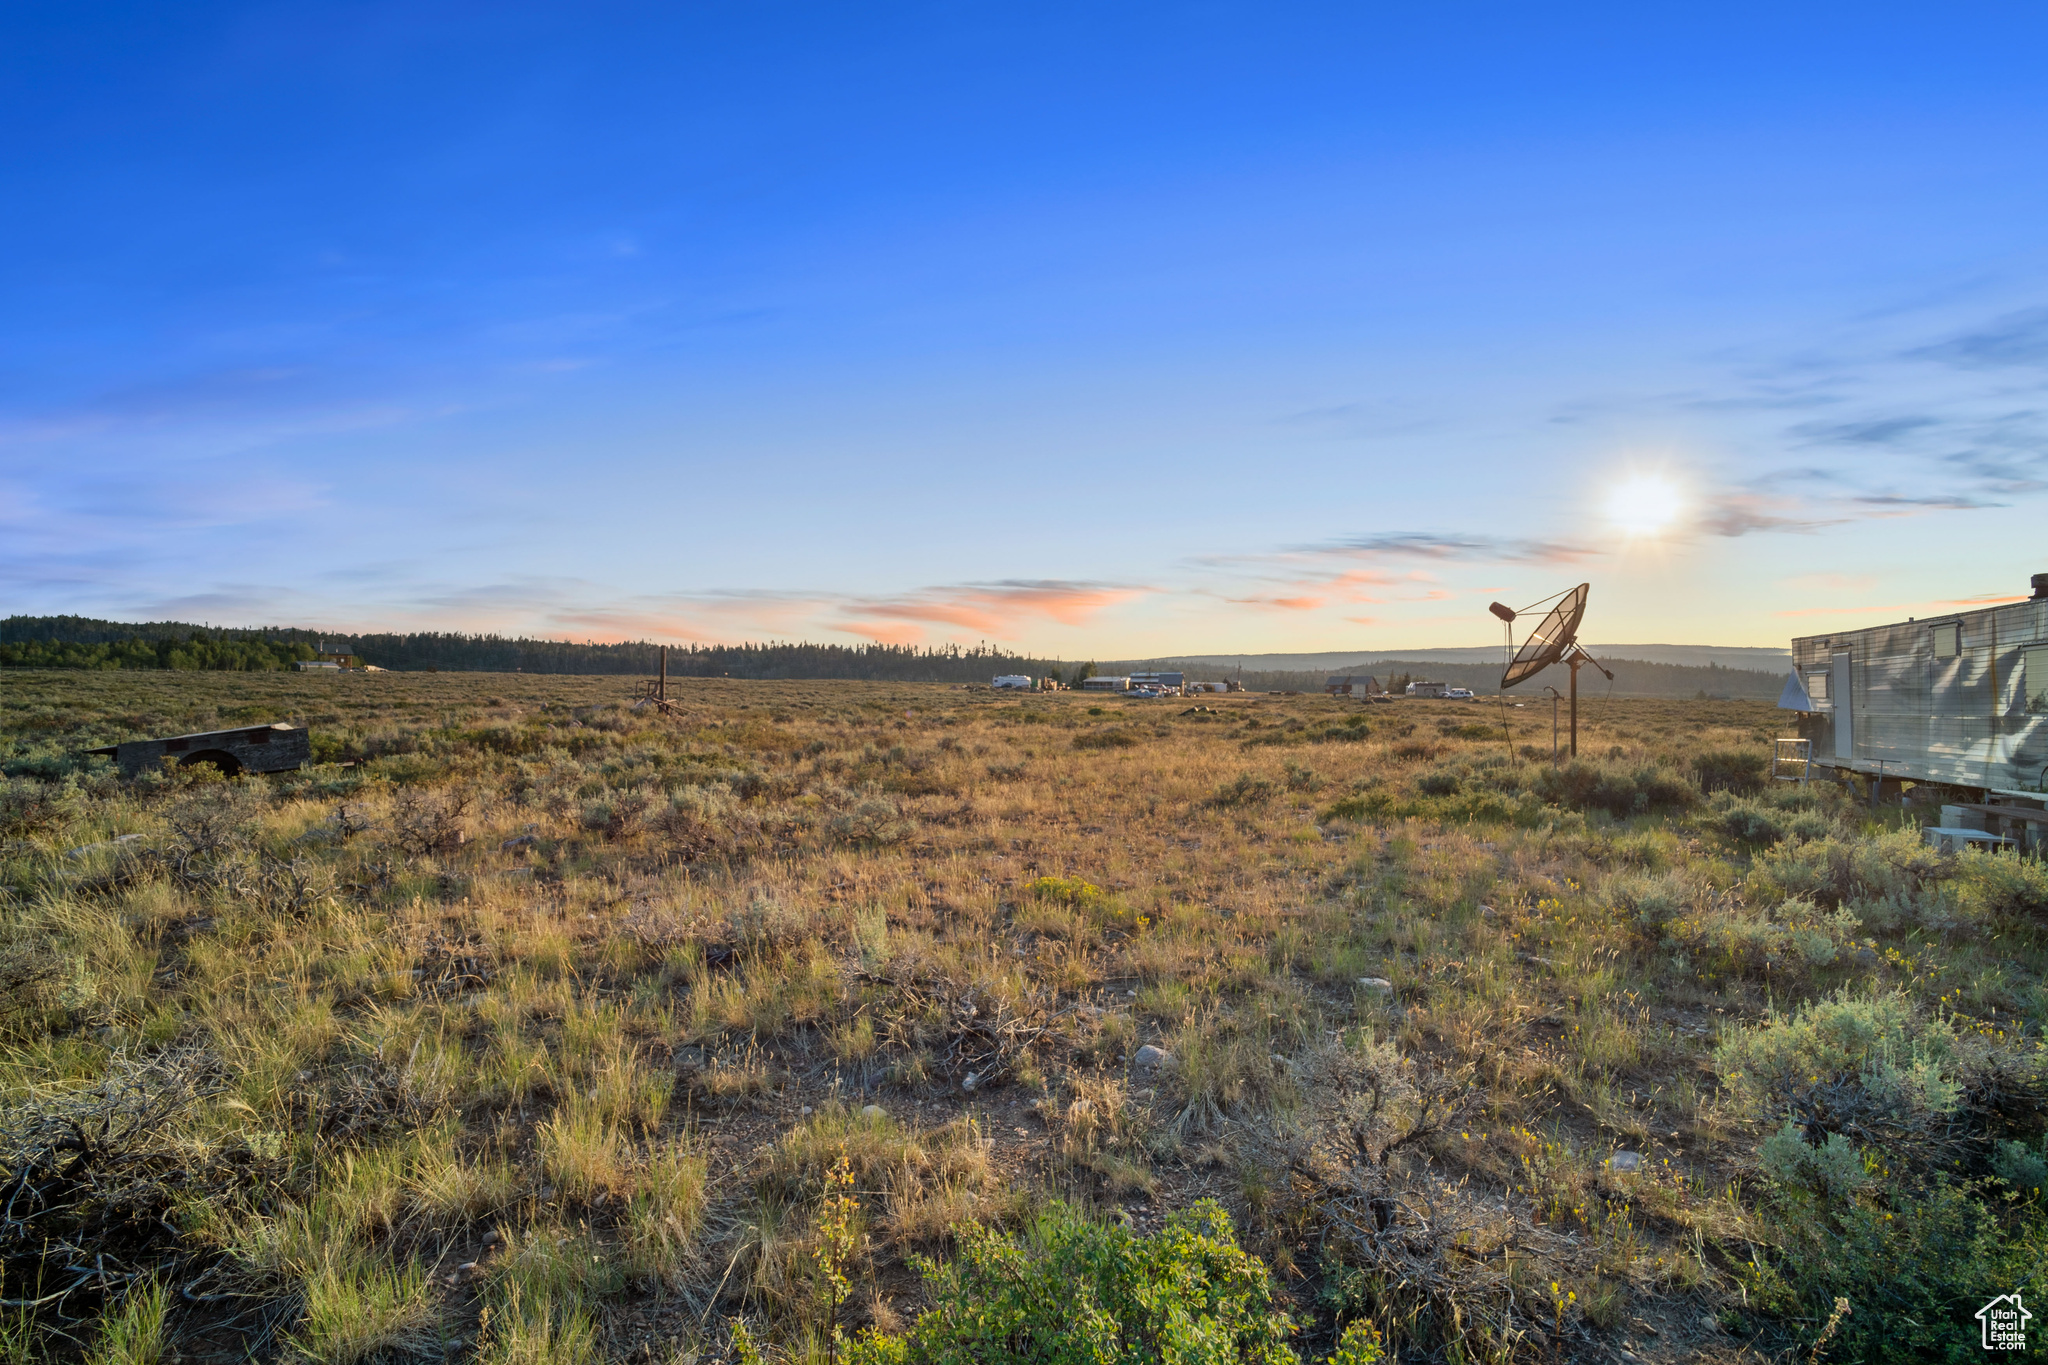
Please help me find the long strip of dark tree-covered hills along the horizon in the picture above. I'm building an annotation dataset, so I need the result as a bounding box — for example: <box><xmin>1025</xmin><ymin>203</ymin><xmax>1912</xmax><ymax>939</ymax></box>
<box><xmin>0</xmin><ymin>616</ymin><xmax>1790</xmax><ymax>700</ymax></box>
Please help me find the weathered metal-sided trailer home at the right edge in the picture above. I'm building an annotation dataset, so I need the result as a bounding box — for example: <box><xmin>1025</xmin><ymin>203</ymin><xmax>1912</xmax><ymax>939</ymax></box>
<box><xmin>1778</xmin><ymin>573</ymin><xmax>2048</xmax><ymax>802</ymax></box>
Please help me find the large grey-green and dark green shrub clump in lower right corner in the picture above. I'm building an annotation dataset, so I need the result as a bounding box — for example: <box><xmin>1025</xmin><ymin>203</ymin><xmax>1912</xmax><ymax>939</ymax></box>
<box><xmin>1716</xmin><ymin>993</ymin><xmax>2048</xmax><ymax>1361</ymax></box>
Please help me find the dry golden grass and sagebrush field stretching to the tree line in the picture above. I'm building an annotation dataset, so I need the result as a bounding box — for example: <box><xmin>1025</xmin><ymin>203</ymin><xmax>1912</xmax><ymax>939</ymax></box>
<box><xmin>0</xmin><ymin>673</ymin><xmax>2048</xmax><ymax>1365</ymax></box>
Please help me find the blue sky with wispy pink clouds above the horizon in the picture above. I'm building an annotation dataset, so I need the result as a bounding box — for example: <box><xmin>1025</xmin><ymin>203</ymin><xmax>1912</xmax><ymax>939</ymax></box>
<box><xmin>0</xmin><ymin>2</ymin><xmax>2048</xmax><ymax>657</ymax></box>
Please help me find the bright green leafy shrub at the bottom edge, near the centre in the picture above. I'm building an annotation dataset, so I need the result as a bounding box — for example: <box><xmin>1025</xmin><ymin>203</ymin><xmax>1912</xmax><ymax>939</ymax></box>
<box><xmin>846</xmin><ymin>1199</ymin><xmax>1318</xmax><ymax>1365</ymax></box>
